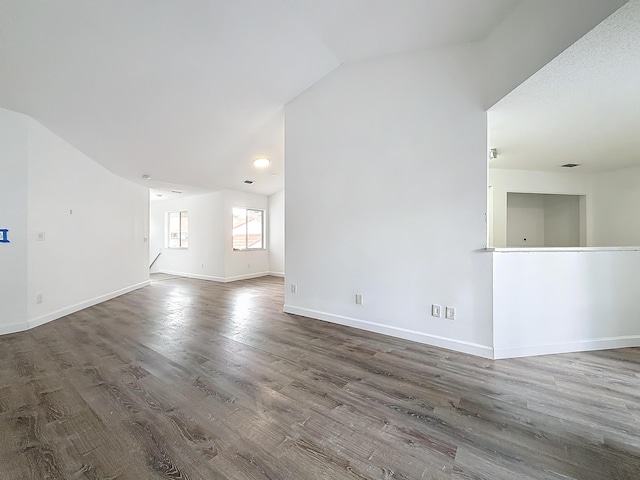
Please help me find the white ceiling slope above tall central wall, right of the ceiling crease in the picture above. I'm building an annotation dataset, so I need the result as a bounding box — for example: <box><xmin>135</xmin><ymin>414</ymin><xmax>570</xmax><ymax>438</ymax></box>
<box><xmin>284</xmin><ymin>0</ymin><xmax>520</xmax><ymax>63</ymax></box>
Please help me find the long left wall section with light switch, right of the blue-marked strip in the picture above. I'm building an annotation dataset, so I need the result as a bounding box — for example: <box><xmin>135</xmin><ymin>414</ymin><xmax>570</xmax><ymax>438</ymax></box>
<box><xmin>27</xmin><ymin>120</ymin><xmax>149</xmax><ymax>325</ymax></box>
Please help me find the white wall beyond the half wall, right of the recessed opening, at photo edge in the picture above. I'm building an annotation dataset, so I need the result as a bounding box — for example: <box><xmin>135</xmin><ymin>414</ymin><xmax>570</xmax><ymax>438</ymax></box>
<box><xmin>594</xmin><ymin>166</ymin><xmax>640</xmax><ymax>246</ymax></box>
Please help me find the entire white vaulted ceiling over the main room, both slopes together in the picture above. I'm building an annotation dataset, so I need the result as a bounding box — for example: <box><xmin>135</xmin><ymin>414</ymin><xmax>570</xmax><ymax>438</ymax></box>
<box><xmin>0</xmin><ymin>0</ymin><xmax>624</xmax><ymax>194</ymax></box>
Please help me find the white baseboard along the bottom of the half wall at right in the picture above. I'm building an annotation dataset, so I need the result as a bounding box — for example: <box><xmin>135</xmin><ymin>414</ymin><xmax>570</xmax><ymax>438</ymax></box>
<box><xmin>494</xmin><ymin>335</ymin><xmax>640</xmax><ymax>359</ymax></box>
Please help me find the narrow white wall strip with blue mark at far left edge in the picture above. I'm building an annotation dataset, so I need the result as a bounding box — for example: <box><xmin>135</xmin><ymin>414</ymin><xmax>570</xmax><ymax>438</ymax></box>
<box><xmin>0</xmin><ymin>109</ymin><xmax>29</xmax><ymax>334</ymax></box>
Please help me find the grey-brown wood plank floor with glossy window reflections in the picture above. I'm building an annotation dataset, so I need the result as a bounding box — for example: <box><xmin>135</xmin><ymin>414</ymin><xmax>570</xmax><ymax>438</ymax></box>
<box><xmin>0</xmin><ymin>276</ymin><xmax>640</xmax><ymax>480</ymax></box>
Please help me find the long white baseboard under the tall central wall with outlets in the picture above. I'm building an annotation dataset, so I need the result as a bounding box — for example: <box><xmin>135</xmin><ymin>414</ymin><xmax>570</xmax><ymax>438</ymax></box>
<box><xmin>283</xmin><ymin>305</ymin><xmax>493</xmax><ymax>359</ymax></box>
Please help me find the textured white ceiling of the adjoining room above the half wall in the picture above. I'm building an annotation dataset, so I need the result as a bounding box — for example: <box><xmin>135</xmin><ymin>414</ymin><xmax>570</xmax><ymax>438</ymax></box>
<box><xmin>489</xmin><ymin>0</ymin><xmax>640</xmax><ymax>173</ymax></box>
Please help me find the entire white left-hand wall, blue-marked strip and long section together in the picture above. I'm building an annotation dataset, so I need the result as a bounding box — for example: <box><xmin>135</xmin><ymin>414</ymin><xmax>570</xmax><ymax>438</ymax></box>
<box><xmin>0</xmin><ymin>110</ymin><xmax>149</xmax><ymax>333</ymax></box>
